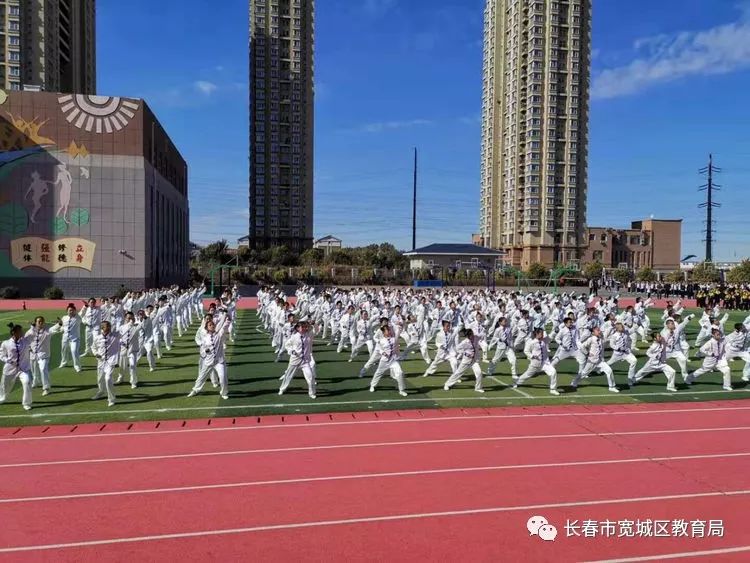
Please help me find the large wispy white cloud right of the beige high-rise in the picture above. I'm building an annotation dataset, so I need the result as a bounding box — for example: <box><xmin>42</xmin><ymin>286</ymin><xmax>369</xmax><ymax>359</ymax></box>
<box><xmin>591</xmin><ymin>12</ymin><xmax>750</xmax><ymax>99</ymax></box>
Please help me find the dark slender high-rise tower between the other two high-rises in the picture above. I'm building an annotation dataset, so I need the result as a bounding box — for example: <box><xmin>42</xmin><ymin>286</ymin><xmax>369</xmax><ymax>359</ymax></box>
<box><xmin>249</xmin><ymin>0</ymin><xmax>314</xmax><ymax>250</ymax></box>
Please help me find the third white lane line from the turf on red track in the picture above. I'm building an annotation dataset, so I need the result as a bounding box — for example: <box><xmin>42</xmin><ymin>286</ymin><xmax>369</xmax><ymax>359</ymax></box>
<box><xmin>0</xmin><ymin>452</ymin><xmax>750</xmax><ymax>504</ymax></box>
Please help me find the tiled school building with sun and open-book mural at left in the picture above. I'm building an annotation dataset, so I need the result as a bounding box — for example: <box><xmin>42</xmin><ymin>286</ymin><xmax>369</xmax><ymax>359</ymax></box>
<box><xmin>0</xmin><ymin>90</ymin><xmax>190</xmax><ymax>297</ymax></box>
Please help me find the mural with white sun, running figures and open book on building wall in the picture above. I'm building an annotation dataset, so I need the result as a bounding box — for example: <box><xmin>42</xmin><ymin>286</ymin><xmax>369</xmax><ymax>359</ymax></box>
<box><xmin>0</xmin><ymin>90</ymin><xmax>139</xmax><ymax>277</ymax></box>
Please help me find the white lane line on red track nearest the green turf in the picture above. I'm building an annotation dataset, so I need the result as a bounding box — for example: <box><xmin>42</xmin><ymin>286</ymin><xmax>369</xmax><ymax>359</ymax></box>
<box><xmin>0</xmin><ymin>406</ymin><xmax>750</xmax><ymax>442</ymax></box>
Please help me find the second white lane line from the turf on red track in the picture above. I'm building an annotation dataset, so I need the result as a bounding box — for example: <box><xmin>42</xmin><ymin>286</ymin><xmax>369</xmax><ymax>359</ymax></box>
<box><xmin>0</xmin><ymin>426</ymin><xmax>750</xmax><ymax>469</ymax></box>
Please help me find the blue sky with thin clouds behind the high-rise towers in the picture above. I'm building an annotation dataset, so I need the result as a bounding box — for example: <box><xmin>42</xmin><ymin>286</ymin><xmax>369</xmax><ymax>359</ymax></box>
<box><xmin>98</xmin><ymin>0</ymin><xmax>750</xmax><ymax>260</ymax></box>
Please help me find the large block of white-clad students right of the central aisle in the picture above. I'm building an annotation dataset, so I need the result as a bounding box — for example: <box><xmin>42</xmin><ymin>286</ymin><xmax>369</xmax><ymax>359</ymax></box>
<box><xmin>259</xmin><ymin>288</ymin><xmax>750</xmax><ymax>400</ymax></box>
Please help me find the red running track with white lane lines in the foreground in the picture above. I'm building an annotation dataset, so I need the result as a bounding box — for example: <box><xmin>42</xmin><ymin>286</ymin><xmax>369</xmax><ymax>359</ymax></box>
<box><xmin>0</xmin><ymin>401</ymin><xmax>750</xmax><ymax>563</ymax></box>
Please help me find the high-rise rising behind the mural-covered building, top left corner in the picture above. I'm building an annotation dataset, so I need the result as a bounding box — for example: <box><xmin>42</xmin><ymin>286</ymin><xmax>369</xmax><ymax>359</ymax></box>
<box><xmin>0</xmin><ymin>0</ymin><xmax>96</xmax><ymax>94</ymax></box>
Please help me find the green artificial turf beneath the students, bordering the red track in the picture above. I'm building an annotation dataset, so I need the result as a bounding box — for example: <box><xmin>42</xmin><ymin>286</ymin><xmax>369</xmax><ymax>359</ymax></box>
<box><xmin>0</xmin><ymin>310</ymin><xmax>750</xmax><ymax>426</ymax></box>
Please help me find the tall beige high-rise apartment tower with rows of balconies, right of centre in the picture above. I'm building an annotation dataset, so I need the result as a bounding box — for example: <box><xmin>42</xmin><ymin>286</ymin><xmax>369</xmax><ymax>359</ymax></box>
<box><xmin>480</xmin><ymin>0</ymin><xmax>591</xmax><ymax>268</ymax></box>
